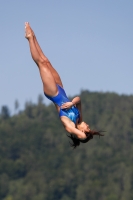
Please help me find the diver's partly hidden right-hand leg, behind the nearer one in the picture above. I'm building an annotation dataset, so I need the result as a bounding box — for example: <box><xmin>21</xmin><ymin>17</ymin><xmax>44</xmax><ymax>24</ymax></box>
<box><xmin>32</xmin><ymin>30</ymin><xmax>63</xmax><ymax>87</ymax></box>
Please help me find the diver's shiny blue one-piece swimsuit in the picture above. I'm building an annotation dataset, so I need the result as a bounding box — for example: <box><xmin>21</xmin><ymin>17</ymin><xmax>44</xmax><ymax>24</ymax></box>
<box><xmin>44</xmin><ymin>85</ymin><xmax>80</xmax><ymax>124</ymax></box>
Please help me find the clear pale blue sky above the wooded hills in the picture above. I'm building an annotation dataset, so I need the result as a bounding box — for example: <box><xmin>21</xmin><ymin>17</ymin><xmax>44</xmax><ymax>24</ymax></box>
<box><xmin>0</xmin><ymin>0</ymin><xmax>133</xmax><ymax>113</ymax></box>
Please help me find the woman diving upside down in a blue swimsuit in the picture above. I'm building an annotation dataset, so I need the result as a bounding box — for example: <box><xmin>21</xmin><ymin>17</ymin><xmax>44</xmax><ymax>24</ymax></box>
<box><xmin>25</xmin><ymin>22</ymin><xmax>103</xmax><ymax>148</ymax></box>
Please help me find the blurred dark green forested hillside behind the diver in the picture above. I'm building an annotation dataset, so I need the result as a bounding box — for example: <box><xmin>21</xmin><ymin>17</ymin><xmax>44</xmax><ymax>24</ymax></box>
<box><xmin>0</xmin><ymin>91</ymin><xmax>133</xmax><ymax>200</ymax></box>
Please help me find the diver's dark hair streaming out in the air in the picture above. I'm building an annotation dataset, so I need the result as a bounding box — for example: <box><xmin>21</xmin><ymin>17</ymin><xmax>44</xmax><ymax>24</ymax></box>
<box><xmin>67</xmin><ymin>130</ymin><xmax>105</xmax><ymax>149</ymax></box>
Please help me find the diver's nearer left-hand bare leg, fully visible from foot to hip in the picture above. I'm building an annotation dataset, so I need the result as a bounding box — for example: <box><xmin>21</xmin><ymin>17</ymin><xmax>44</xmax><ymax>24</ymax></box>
<box><xmin>25</xmin><ymin>23</ymin><xmax>58</xmax><ymax>96</ymax></box>
